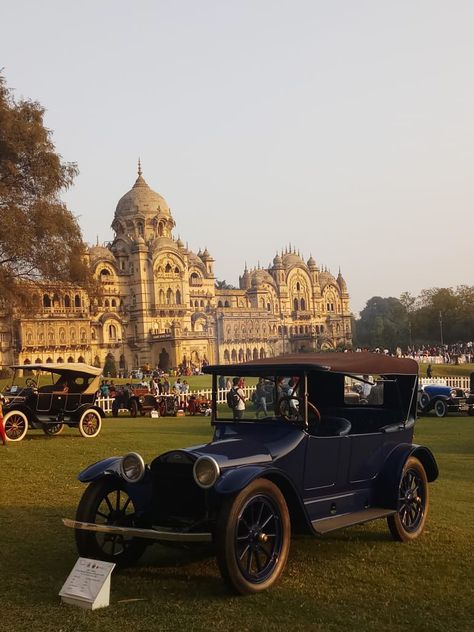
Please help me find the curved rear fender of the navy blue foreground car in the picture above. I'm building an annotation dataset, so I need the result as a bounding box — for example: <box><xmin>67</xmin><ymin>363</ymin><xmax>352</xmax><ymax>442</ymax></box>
<box><xmin>376</xmin><ymin>443</ymin><xmax>439</xmax><ymax>509</ymax></box>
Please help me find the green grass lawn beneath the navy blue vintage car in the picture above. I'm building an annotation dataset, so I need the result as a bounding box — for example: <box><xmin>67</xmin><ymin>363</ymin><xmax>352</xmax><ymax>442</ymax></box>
<box><xmin>0</xmin><ymin>416</ymin><xmax>474</xmax><ymax>632</ymax></box>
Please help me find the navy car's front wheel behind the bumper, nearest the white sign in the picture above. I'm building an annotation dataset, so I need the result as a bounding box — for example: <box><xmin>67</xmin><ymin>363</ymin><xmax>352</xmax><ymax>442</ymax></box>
<box><xmin>75</xmin><ymin>476</ymin><xmax>147</xmax><ymax>567</ymax></box>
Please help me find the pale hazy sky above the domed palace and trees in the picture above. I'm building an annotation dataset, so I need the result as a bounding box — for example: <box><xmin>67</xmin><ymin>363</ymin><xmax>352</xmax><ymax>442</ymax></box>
<box><xmin>0</xmin><ymin>0</ymin><xmax>474</xmax><ymax>312</ymax></box>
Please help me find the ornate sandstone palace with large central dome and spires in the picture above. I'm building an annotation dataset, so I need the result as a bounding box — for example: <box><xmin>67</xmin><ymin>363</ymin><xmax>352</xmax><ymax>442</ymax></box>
<box><xmin>0</xmin><ymin>164</ymin><xmax>352</xmax><ymax>372</ymax></box>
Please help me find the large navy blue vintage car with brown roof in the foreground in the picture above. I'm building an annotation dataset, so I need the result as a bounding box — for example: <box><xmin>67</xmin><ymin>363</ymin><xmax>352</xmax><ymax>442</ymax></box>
<box><xmin>64</xmin><ymin>353</ymin><xmax>438</xmax><ymax>594</ymax></box>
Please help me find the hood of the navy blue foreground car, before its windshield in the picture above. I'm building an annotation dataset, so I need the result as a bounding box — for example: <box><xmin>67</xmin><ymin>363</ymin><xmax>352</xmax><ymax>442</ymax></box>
<box><xmin>184</xmin><ymin>437</ymin><xmax>272</xmax><ymax>469</ymax></box>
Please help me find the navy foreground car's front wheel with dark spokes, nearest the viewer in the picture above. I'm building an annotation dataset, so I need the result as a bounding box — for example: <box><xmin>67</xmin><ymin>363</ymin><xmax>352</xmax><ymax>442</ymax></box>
<box><xmin>215</xmin><ymin>479</ymin><xmax>291</xmax><ymax>595</ymax></box>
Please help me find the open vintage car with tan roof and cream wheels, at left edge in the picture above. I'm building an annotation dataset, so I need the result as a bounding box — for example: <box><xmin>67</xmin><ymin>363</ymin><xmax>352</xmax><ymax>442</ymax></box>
<box><xmin>3</xmin><ymin>363</ymin><xmax>104</xmax><ymax>441</ymax></box>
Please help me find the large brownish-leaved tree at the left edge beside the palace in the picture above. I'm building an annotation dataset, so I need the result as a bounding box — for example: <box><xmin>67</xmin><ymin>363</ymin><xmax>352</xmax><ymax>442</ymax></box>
<box><xmin>0</xmin><ymin>75</ymin><xmax>89</xmax><ymax>304</ymax></box>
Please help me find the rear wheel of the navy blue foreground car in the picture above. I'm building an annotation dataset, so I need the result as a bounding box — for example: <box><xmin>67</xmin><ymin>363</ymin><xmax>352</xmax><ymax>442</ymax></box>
<box><xmin>387</xmin><ymin>456</ymin><xmax>429</xmax><ymax>542</ymax></box>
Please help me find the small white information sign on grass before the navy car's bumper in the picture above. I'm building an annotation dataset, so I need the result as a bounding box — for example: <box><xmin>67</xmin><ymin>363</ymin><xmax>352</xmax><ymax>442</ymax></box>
<box><xmin>59</xmin><ymin>557</ymin><xmax>115</xmax><ymax>610</ymax></box>
